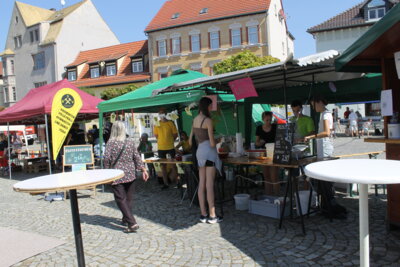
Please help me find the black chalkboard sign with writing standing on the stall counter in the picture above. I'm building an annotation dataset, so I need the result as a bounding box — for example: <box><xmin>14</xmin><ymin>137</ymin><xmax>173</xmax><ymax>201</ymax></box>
<box><xmin>273</xmin><ymin>123</ymin><xmax>295</xmax><ymax>164</ymax></box>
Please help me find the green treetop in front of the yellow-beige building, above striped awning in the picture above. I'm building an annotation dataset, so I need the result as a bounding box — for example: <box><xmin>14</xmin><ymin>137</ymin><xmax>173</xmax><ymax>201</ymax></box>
<box><xmin>213</xmin><ymin>50</ymin><xmax>280</xmax><ymax>74</ymax></box>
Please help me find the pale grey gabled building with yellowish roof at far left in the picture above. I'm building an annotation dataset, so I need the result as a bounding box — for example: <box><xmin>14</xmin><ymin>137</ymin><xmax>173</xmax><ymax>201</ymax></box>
<box><xmin>0</xmin><ymin>0</ymin><xmax>119</xmax><ymax>106</ymax></box>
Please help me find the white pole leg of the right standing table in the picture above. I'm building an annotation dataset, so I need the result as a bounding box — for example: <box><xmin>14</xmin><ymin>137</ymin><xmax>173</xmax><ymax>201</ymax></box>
<box><xmin>359</xmin><ymin>184</ymin><xmax>369</xmax><ymax>267</ymax></box>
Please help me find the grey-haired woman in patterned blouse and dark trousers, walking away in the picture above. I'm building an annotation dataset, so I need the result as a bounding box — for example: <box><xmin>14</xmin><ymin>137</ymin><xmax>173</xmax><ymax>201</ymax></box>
<box><xmin>104</xmin><ymin>121</ymin><xmax>149</xmax><ymax>233</ymax></box>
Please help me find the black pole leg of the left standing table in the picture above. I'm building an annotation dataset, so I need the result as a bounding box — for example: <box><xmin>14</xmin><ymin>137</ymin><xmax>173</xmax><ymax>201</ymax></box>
<box><xmin>69</xmin><ymin>189</ymin><xmax>85</xmax><ymax>267</ymax></box>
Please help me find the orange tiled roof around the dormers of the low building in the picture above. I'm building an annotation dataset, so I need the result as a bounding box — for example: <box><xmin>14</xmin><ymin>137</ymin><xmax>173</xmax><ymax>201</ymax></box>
<box><xmin>66</xmin><ymin>40</ymin><xmax>150</xmax><ymax>87</ymax></box>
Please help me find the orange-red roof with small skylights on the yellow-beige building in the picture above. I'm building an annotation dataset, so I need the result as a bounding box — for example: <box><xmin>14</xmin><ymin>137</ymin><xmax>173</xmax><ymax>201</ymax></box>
<box><xmin>145</xmin><ymin>0</ymin><xmax>271</xmax><ymax>32</ymax></box>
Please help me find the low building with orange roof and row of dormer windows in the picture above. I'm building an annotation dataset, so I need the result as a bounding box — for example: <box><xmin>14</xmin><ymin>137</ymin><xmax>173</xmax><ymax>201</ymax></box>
<box><xmin>65</xmin><ymin>40</ymin><xmax>151</xmax><ymax>97</ymax></box>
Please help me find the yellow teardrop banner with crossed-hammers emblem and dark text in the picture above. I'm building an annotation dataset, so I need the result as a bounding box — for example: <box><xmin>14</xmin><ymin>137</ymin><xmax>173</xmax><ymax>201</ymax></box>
<box><xmin>51</xmin><ymin>88</ymin><xmax>82</xmax><ymax>159</ymax></box>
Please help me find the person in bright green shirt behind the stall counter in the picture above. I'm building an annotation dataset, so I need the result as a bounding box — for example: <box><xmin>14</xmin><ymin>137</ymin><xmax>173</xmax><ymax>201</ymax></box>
<box><xmin>290</xmin><ymin>100</ymin><xmax>315</xmax><ymax>142</ymax></box>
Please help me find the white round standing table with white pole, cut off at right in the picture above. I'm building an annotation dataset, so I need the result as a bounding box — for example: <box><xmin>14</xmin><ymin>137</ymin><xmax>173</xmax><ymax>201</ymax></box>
<box><xmin>305</xmin><ymin>159</ymin><xmax>400</xmax><ymax>267</ymax></box>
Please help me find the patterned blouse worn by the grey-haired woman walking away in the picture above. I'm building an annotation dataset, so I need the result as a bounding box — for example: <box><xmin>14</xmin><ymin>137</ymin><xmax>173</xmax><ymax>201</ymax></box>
<box><xmin>104</xmin><ymin>138</ymin><xmax>144</xmax><ymax>185</ymax></box>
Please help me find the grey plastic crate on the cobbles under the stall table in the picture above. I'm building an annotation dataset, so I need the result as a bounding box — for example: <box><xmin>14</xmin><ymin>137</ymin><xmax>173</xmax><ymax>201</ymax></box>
<box><xmin>249</xmin><ymin>196</ymin><xmax>290</xmax><ymax>219</ymax></box>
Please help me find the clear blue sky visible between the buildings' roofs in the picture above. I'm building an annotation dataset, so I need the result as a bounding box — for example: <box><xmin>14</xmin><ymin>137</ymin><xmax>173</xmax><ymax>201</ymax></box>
<box><xmin>0</xmin><ymin>0</ymin><xmax>363</xmax><ymax>57</ymax></box>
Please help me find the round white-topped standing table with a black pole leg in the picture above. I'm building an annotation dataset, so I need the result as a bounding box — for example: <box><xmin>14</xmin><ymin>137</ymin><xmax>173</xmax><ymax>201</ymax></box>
<box><xmin>14</xmin><ymin>169</ymin><xmax>124</xmax><ymax>267</ymax></box>
